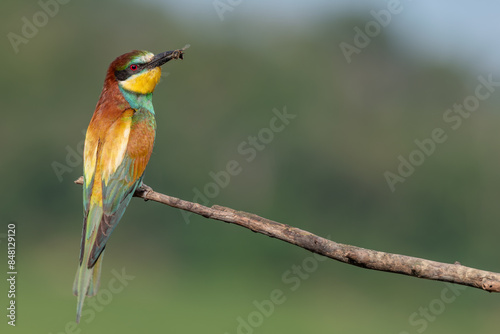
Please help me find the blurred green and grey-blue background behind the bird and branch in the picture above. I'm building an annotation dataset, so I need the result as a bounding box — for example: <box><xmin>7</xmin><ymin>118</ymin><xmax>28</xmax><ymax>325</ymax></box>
<box><xmin>0</xmin><ymin>0</ymin><xmax>500</xmax><ymax>334</ymax></box>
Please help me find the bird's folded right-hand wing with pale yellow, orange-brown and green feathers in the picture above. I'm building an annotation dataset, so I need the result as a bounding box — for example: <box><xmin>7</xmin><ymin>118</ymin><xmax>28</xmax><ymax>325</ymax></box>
<box><xmin>88</xmin><ymin>109</ymin><xmax>156</xmax><ymax>267</ymax></box>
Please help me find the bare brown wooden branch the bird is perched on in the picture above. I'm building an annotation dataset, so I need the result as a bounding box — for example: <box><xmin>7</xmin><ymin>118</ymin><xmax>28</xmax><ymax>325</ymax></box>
<box><xmin>75</xmin><ymin>177</ymin><xmax>500</xmax><ymax>292</ymax></box>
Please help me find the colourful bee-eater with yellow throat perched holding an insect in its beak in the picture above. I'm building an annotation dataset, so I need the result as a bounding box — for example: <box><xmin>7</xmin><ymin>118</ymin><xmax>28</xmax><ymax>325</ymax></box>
<box><xmin>73</xmin><ymin>49</ymin><xmax>184</xmax><ymax>322</ymax></box>
